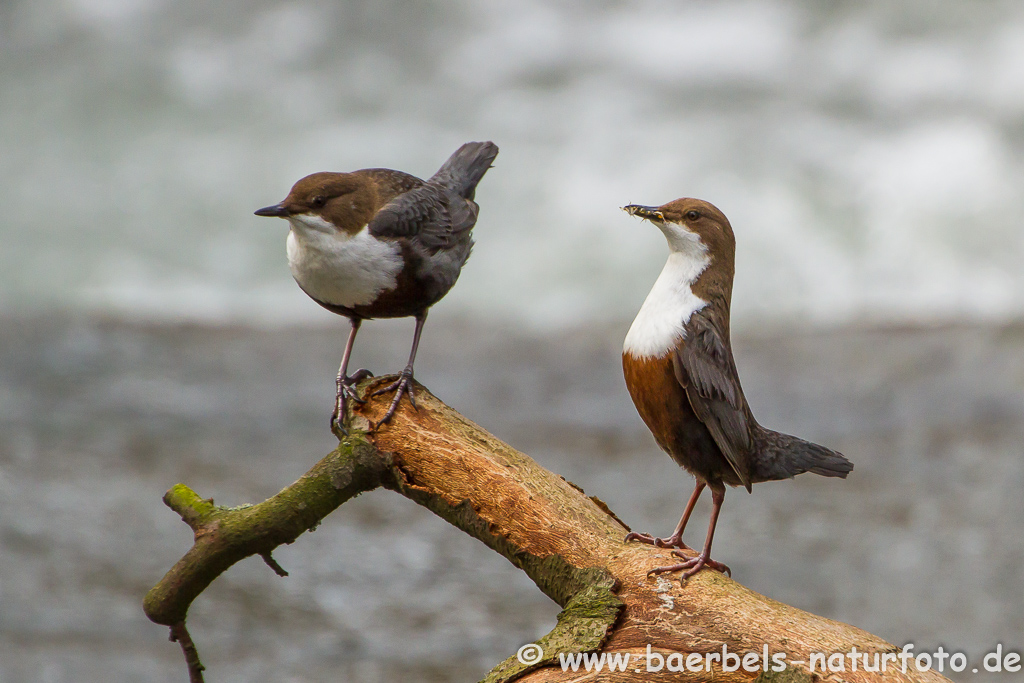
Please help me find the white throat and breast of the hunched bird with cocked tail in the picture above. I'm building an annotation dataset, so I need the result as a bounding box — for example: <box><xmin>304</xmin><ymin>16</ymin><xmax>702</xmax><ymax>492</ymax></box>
<box><xmin>288</xmin><ymin>215</ymin><xmax>402</xmax><ymax>307</ymax></box>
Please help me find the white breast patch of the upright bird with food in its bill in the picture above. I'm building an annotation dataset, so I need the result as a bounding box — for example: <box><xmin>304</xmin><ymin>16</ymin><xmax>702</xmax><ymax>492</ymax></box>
<box><xmin>623</xmin><ymin>249</ymin><xmax>711</xmax><ymax>359</ymax></box>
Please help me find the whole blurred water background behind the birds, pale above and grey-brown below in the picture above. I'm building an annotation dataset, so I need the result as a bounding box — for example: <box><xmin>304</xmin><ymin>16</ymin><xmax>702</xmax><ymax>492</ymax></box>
<box><xmin>0</xmin><ymin>0</ymin><xmax>1024</xmax><ymax>683</ymax></box>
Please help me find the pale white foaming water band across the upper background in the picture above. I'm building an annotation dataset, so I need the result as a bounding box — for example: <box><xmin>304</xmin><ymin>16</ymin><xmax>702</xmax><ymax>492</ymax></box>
<box><xmin>0</xmin><ymin>0</ymin><xmax>1024</xmax><ymax>327</ymax></box>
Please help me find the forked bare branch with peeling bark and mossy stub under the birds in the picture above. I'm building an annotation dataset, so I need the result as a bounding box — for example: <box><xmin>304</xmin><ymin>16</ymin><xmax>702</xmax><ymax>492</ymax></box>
<box><xmin>144</xmin><ymin>378</ymin><xmax>947</xmax><ymax>683</ymax></box>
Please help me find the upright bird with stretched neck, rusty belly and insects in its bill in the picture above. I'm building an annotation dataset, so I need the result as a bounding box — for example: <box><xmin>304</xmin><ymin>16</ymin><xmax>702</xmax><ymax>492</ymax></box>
<box><xmin>623</xmin><ymin>199</ymin><xmax>853</xmax><ymax>581</ymax></box>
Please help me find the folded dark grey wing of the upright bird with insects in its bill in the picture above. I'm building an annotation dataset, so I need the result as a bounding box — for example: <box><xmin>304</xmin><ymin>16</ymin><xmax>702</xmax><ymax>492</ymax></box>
<box><xmin>672</xmin><ymin>311</ymin><xmax>755</xmax><ymax>490</ymax></box>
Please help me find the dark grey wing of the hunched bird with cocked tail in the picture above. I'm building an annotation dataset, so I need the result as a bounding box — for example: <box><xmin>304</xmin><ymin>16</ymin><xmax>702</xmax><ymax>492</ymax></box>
<box><xmin>368</xmin><ymin>183</ymin><xmax>479</xmax><ymax>253</ymax></box>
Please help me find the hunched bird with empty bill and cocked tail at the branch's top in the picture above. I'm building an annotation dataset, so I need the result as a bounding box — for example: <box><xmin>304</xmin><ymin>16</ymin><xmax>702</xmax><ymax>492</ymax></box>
<box><xmin>256</xmin><ymin>142</ymin><xmax>498</xmax><ymax>432</ymax></box>
